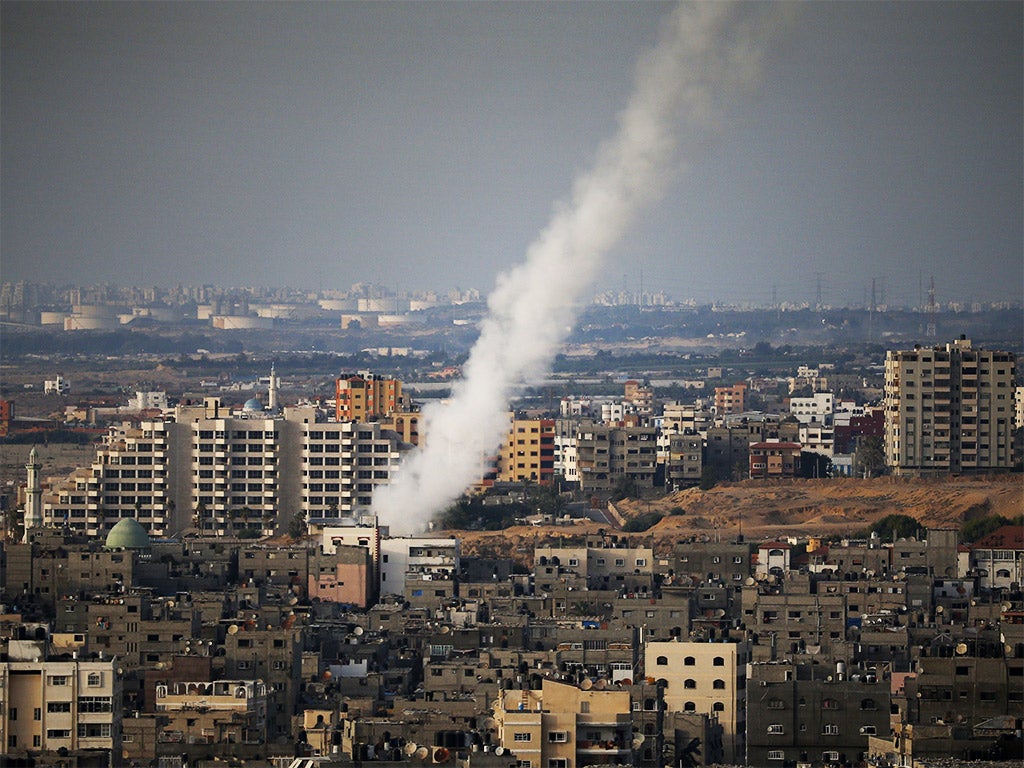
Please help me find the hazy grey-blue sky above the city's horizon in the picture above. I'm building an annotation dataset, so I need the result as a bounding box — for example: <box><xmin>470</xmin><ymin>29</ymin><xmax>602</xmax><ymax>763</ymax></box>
<box><xmin>0</xmin><ymin>2</ymin><xmax>1024</xmax><ymax>303</ymax></box>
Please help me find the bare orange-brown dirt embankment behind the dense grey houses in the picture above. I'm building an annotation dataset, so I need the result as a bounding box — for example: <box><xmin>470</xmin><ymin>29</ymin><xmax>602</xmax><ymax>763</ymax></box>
<box><xmin>459</xmin><ymin>475</ymin><xmax>1024</xmax><ymax>562</ymax></box>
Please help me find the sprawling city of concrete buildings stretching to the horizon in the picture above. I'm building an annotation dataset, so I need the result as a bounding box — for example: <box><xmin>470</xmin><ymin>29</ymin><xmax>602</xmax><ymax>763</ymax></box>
<box><xmin>0</xmin><ymin>285</ymin><xmax>1024</xmax><ymax>768</ymax></box>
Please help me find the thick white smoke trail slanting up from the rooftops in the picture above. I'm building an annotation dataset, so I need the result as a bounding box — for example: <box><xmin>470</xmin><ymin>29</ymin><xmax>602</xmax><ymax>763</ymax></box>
<box><xmin>374</xmin><ymin>0</ymin><xmax>777</xmax><ymax>534</ymax></box>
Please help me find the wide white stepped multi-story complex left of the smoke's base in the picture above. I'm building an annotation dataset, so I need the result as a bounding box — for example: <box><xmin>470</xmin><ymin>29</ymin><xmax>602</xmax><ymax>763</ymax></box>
<box><xmin>42</xmin><ymin>397</ymin><xmax>410</xmax><ymax>537</ymax></box>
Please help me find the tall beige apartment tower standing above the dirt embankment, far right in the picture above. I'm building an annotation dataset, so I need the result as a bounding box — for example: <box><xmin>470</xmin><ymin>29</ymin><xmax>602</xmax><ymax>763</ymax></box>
<box><xmin>885</xmin><ymin>338</ymin><xmax>1017</xmax><ymax>475</ymax></box>
